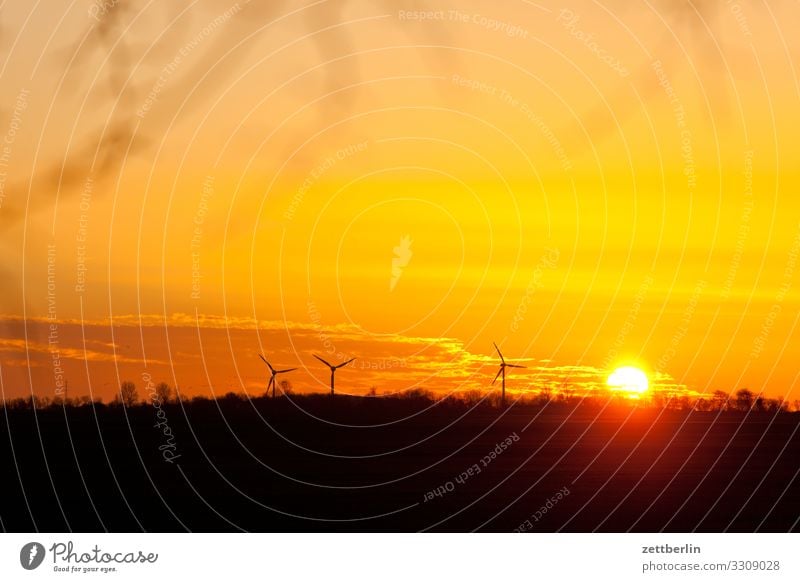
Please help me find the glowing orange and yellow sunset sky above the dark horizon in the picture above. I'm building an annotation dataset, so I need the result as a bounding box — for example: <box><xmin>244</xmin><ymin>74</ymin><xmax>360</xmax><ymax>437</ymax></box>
<box><xmin>0</xmin><ymin>0</ymin><xmax>800</xmax><ymax>399</ymax></box>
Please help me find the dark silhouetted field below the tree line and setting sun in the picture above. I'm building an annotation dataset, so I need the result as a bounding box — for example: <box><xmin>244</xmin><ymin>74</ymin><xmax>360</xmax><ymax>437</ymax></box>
<box><xmin>0</xmin><ymin>394</ymin><xmax>800</xmax><ymax>532</ymax></box>
